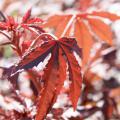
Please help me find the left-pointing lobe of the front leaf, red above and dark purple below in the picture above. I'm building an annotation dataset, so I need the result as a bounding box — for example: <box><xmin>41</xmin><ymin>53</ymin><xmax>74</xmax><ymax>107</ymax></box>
<box><xmin>17</xmin><ymin>41</ymin><xmax>55</xmax><ymax>69</ymax></box>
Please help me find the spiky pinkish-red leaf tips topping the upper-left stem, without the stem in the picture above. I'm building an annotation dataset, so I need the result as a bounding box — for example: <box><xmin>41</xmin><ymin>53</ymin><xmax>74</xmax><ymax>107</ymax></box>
<box><xmin>0</xmin><ymin>9</ymin><xmax>43</xmax><ymax>32</ymax></box>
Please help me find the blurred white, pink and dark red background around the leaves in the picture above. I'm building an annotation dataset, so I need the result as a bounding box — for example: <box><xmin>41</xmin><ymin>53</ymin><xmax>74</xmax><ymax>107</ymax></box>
<box><xmin>0</xmin><ymin>0</ymin><xmax>120</xmax><ymax>120</ymax></box>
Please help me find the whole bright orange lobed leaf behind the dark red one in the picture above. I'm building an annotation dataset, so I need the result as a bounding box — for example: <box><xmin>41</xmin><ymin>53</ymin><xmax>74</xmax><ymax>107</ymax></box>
<box><xmin>42</xmin><ymin>11</ymin><xmax>120</xmax><ymax>66</ymax></box>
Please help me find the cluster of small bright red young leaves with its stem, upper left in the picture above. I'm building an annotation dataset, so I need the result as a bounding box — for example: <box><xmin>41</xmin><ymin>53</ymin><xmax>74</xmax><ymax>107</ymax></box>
<box><xmin>0</xmin><ymin>9</ymin><xmax>45</xmax><ymax>56</ymax></box>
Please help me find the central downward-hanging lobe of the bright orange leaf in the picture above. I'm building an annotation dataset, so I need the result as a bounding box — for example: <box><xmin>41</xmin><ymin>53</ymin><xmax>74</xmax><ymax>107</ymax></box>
<box><xmin>75</xmin><ymin>20</ymin><xmax>94</xmax><ymax>67</ymax></box>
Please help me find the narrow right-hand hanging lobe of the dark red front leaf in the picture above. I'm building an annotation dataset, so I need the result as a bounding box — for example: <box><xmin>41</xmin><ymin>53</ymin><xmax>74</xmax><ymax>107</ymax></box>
<box><xmin>62</xmin><ymin>43</ymin><xmax>82</xmax><ymax>109</ymax></box>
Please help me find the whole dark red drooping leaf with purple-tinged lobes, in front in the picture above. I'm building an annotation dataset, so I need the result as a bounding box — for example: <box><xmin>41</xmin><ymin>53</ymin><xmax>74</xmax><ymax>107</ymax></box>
<box><xmin>7</xmin><ymin>38</ymin><xmax>82</xmax><ymax>120</ymax></box>
